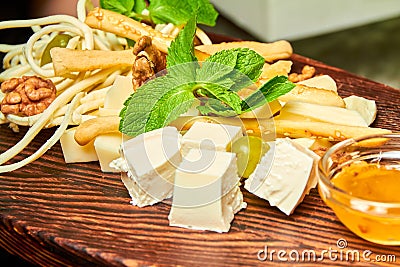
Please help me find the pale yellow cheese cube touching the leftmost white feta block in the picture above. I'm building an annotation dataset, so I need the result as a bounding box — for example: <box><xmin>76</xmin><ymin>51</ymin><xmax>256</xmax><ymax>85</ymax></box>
<box><xmin>94</xmin><ymin>133</ymin><xmax>122</xmax><ymax>172</ymax></box>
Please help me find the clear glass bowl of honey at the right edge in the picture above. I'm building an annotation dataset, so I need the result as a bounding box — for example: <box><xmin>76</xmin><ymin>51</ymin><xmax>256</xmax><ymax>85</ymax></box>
<box><xmin>318</xmin><ymin>133</ymin><xmax>400</xmax><ymax>245</ymax></box>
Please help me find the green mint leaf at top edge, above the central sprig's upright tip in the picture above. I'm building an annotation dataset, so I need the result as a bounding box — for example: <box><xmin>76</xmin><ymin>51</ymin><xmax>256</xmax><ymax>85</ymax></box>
<box><xmin>148</xmin><ymin>0</ymin><xmax>218</xmax><ymax>26</ymax></box>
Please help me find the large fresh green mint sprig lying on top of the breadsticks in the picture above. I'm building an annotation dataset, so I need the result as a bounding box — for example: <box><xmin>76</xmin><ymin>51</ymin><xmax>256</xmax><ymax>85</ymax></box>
<box><xmin>120</xmin><ymin>16</ymin><xmax>295</xmax><ymax>136</ymax></box>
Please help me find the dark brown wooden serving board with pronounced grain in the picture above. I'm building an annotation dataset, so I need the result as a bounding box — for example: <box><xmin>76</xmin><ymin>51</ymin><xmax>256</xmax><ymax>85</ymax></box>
<box><xmin>0</xmin><ymin>34</ymin><xmax>400</xmax><ymax>266</ymax></box>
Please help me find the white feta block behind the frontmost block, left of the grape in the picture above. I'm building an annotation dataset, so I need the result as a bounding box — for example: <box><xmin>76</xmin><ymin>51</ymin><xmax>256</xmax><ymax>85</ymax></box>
<box><xmin>182</xmin><ymin>121</ymin><xmax>243</xmax><ymax>156</ymax></box>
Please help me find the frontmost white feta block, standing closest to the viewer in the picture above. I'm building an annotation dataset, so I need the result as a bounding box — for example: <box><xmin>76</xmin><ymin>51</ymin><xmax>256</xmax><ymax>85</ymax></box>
<box><xmin>168</xmin><ymin>149</ymin><xmax>246</xmax><ymax>232</ymax></box>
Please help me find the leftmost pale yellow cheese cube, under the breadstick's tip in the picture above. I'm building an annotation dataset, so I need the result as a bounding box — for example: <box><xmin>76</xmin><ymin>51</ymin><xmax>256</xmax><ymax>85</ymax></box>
<box><xmin>60</xmin><ymin>127</ymin><xmax>98</xmax><ymax>163</ymax></box>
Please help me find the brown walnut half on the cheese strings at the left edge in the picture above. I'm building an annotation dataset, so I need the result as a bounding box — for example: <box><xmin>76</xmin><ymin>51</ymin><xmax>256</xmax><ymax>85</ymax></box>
<box><xmin>0</xmin><ymin>76</ymin><xmax>56</xmax><ymax>116</ymax></box>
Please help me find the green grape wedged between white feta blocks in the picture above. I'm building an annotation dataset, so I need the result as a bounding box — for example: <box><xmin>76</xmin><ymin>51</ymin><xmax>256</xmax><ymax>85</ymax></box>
<box><xmin>228</xmin><ymin>136</ymin><xmax>269</xmax><ymax>178</ymax></box>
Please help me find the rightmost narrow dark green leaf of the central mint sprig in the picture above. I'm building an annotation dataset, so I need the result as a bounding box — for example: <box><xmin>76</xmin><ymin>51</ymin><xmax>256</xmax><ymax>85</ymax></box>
<box><xmin>242</xmin><ymin>76</ymin><xmax>296</xmax><ymax>112</ymax></box>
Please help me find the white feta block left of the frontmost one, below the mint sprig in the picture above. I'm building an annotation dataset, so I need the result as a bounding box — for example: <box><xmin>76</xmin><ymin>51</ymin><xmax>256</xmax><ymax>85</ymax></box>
<box><xmin>118</xmin><ymin>127</ymin><xmax>182</xmax><ymax>207</ymax></box>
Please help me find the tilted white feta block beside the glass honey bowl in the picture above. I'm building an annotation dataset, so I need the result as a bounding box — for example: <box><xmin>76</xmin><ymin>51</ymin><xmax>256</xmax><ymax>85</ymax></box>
<box><xmin>245</xmin><ymin>138</ymin><xmax>314</xmax><ymax>215</ymax></box>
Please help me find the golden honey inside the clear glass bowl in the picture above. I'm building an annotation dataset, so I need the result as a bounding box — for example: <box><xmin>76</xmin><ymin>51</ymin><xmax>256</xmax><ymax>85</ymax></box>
<box><xmin>324</xmin><ymin>161</ymin><xmax>400</xmax><ymax>245</ymax></box>
